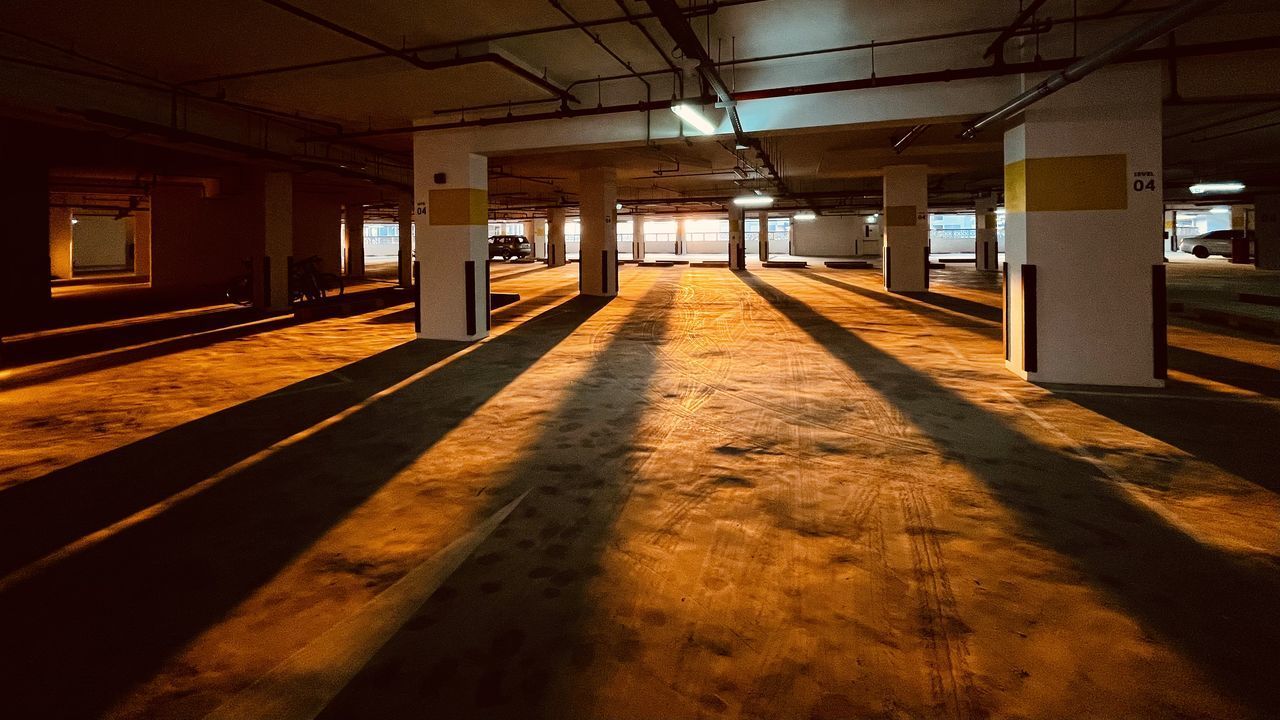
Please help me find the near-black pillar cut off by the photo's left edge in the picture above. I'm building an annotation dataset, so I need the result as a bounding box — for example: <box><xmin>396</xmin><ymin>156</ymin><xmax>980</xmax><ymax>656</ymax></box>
<box><xmin>0</xmin><ymin>139</ymin><xmax>50</xmax><ymax>336</ymax></box>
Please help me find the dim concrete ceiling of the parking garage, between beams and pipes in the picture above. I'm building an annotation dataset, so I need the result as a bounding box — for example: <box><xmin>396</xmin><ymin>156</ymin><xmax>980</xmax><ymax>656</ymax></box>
<box><xmin>0</xmin><ymin>0</ymin><xmax>1280</xmax><ymax>213</ymax></box>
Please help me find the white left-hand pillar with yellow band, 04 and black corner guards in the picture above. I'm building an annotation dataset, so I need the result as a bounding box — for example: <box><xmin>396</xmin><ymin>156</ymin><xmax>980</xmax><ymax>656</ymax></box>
<box><xmin>413</xmin><ymin>146</ymin><xmax>489</xmax><ymax>341</ymax></box>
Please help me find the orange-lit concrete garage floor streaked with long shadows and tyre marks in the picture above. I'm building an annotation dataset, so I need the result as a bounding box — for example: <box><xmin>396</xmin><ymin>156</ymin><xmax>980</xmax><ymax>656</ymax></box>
<box><xmin>0</xmin><ymin>260</ymin><xmax>1280</xmax><ymax>719</ymax></box>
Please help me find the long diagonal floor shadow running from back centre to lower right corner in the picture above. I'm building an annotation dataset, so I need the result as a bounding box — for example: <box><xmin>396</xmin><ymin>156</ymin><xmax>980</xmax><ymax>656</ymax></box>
<box><xmin>739</xmin><ymin>275</ymin><xmax>1280</xmax><ymax>717</ymax></box>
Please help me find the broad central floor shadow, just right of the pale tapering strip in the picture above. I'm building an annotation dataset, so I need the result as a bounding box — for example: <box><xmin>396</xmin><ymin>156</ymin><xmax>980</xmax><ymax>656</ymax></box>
<box><xmin>323</xmin><ymin>275</ymin><xmax>678</xmax><ymax>719</ymax></box>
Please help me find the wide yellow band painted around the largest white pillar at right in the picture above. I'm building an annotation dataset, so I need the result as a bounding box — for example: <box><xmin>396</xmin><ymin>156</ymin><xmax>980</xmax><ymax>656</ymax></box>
<box><xmin>1005</xmin><ymin>155</ymin><xmax>1129</xmax><ymax>213</ymax></box>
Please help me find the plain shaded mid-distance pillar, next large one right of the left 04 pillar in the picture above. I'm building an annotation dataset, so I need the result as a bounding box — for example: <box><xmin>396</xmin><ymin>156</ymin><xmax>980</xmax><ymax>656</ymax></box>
<box><xmin>577</xmin><ymin>168</ymin><xmax>618</xmax><ymax>297</ymax></box>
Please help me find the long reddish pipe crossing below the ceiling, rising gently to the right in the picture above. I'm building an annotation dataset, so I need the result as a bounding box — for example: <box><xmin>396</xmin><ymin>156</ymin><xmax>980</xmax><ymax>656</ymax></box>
<box><xmin>302</xmin><ymin>35</ymin><xmax>1280</xmax><ymax>142</ymax></box>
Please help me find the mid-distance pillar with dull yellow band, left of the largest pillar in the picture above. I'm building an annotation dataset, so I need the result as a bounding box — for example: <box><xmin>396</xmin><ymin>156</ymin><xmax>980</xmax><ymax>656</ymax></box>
<box><xmin>882</xmin><ymin>165</ymin><xmax>929</xmax><ymax>292</ymax></box>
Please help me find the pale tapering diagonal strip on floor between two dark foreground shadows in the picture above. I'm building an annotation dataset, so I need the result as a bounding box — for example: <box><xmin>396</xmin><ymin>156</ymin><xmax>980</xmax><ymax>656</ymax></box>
<box><xmin>205</xmin><ymin>491</ymin><xmax>529</xmax><ymax>720</ymax></box>
